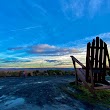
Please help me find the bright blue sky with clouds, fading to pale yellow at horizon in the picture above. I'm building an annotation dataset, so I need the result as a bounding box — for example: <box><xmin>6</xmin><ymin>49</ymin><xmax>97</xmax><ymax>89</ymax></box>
<box><xmin>0</xmin><ymin>0</ymin><xmax>110</xmax><ymax>68</ymax></box>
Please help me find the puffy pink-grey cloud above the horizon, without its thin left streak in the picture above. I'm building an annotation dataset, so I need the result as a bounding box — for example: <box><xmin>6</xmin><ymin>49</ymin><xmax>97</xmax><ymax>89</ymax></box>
<box><xmin>27</xmin><ymin>44</ymin><xmax>81</xmax><ymax>56</ymax></box>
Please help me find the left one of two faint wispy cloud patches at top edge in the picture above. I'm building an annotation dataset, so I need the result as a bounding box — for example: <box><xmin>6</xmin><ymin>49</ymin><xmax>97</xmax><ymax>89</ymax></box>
<box><xmin>61</xmin><ymin>0</ymin><xmax>85</xmax><ymax>19</ymax></box>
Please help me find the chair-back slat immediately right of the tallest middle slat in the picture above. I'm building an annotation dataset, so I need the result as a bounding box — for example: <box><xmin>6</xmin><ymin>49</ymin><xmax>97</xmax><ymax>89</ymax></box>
<box><xmin>98</xmin><ymin>39</ymin><xmax>103</xmax><ymax>82</ymax></box>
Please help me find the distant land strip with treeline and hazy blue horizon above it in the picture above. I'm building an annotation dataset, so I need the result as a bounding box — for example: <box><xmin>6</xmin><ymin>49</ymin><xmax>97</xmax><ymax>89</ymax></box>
<box><xmin>0</xmin><ymin>68</ymin><xmax>74</xmax><ymax>77</ymax></box>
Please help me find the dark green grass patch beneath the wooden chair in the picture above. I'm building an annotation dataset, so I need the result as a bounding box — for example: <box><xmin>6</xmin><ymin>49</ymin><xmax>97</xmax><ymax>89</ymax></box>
<box><xmin>64</xmin><ymin>83</ymin><xmax>110</xmax><ymax>108</ymax></box>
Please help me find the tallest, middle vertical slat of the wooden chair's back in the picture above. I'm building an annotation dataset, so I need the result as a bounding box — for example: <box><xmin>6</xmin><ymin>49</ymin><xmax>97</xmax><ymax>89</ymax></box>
<box><xmin>94</xmin><ymin>37</ymin><xmax>99</xmax><ymax>82</ymax></box>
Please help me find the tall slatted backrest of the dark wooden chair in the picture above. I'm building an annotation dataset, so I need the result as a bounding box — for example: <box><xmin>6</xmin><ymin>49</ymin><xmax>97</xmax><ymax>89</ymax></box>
<box><xmin>86</xmin><ymin>37</ymin><xmax>110</xmax><ymax>83</ymax></box>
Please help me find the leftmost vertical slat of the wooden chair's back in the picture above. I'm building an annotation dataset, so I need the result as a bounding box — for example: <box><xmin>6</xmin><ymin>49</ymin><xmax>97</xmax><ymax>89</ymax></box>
<box><xmin>86</xmin><ymin>42</ymin><xmax>90</xmax><ymax>82</ymax></box>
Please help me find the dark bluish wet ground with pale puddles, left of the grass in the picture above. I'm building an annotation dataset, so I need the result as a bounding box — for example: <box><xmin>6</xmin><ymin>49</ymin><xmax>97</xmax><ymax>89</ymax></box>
<box><xmin>0</xmin><ymin>76</ymin><xmax>108</xmax><ymax>110</ymax></box>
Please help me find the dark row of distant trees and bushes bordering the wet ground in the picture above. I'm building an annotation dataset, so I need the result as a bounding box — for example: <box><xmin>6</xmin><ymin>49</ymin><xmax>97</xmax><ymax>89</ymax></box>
<box><xmin>0</xmin><ymin>70</ymin><xmax>74</xmax><ymax>77</ymax></box>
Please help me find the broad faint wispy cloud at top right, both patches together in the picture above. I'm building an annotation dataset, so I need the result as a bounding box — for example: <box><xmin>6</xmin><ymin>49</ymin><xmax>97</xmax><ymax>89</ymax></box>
<box><xmin>61</xmin><ymin>0</ymin><xmax>105</xmax><ymax>20</ymax></box>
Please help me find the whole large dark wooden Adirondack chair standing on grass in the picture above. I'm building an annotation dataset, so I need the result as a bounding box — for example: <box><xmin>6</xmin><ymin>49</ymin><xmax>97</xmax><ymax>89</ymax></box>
<box><xmin>71</xmin><ymin>37</ymin><xmax>110</xmax><ymax>92</ymax></box>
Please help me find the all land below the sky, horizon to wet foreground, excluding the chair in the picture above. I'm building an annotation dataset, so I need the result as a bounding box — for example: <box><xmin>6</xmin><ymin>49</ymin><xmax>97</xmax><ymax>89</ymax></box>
<box><xmin>0</xmin><ymin>68</ymin><xmax>110</xmax><ymax>110</ymax></box>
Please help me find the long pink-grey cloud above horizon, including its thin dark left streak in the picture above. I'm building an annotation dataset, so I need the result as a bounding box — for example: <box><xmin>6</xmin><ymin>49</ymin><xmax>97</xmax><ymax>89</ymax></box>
<box><xmin>8</xmin><ymin>44</ymin><xmax>82</xmax><ymax>56</ymax></box>
